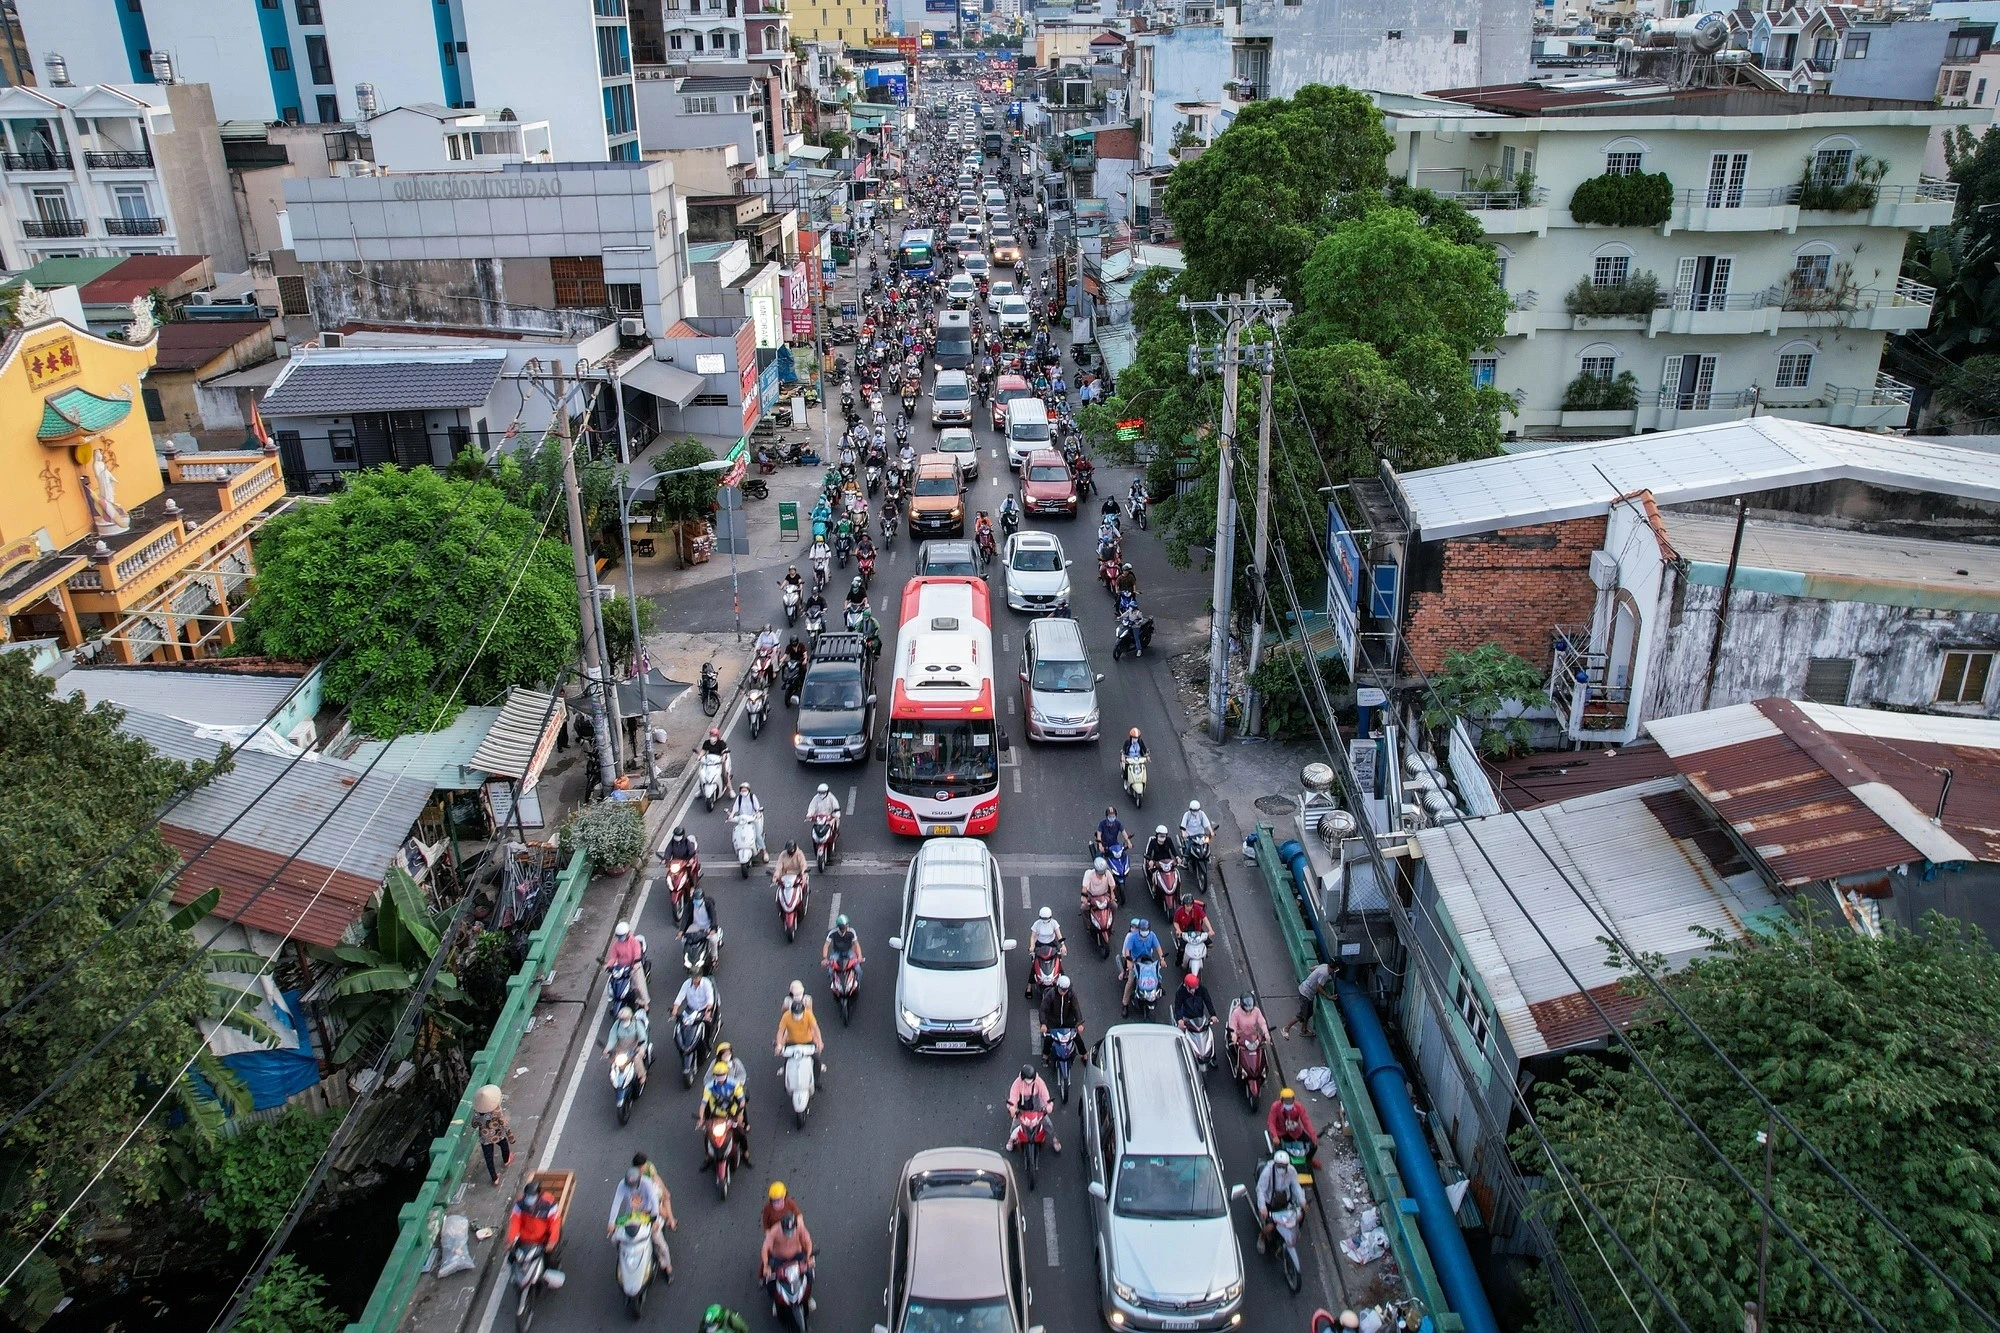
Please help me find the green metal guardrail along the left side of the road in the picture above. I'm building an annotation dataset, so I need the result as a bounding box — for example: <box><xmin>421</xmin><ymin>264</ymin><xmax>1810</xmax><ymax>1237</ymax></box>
<box><xmin>346</xmin><ymin>853</ymin><xmax>590</xmax><ymax>1333</ymax></box>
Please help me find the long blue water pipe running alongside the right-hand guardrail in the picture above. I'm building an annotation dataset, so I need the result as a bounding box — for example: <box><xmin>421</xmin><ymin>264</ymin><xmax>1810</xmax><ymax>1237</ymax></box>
<box><xmin>1278</xmin><ymin>839</ymin><xmax>1500</xmax><ymax>1333</ymax></box>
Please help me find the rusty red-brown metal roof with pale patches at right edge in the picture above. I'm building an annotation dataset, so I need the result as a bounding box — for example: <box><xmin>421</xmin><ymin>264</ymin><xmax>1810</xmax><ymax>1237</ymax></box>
<box><xmin>1646</xmin><ymin>699</ymin><xmax>2000</xmax><ymax>887</ymax></box>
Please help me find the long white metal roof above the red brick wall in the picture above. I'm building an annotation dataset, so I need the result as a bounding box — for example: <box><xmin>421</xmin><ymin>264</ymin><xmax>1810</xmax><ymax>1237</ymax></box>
<box><xmin>1396</xmin><ymin>416</ymin><xmax>2000</xmax><ymax>540</ymax></box>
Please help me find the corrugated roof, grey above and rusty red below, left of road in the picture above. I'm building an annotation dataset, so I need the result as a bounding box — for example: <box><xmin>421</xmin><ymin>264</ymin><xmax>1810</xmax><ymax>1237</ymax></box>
<box><xmin>122</xmin><ymin>713</ymin><xmax>430</xmax><ymax>947</ymax></box>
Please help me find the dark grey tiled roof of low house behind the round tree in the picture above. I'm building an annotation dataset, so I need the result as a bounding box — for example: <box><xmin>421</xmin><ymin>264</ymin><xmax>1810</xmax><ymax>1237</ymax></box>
<box><xmin>258</xmin><ymin>348</ymin><xmax>506</xmax><ymax>418</ymax></box>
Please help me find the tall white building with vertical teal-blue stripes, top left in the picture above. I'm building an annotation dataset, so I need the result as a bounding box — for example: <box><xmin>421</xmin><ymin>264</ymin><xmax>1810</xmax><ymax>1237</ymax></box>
<box><xmin>16</xmin><ymin>0</ymin><xmax>638</xmax><ymax>162</ymax></box>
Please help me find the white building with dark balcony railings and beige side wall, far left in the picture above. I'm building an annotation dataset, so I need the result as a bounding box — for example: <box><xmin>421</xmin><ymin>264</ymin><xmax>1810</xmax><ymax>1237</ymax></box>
<box><xmin>0</xmin><ymin>84</ymin><xmax>248</xmax><ymax>272</ymax></box>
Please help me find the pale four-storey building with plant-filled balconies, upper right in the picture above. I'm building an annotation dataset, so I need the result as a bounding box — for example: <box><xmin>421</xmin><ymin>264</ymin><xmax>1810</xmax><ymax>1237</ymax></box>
<box><xmin>1378</xmin><ymin>82</ymin><xmax>1976</xmax><ymax>436</ymax></box>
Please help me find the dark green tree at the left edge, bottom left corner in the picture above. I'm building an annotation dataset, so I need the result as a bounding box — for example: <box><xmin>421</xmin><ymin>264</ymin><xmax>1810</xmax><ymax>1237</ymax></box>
<box><xmin>0</xmin><ymin>652</ymin><xmax>210</xmax><ymax>1327</ymax></box>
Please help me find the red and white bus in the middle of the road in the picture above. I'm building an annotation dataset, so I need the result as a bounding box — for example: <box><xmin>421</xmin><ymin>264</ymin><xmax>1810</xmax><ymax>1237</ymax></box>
<box><xmin>884</xmin><ymin>578</ymin><xmax>1000</xmax><ymax>837</ymax></box>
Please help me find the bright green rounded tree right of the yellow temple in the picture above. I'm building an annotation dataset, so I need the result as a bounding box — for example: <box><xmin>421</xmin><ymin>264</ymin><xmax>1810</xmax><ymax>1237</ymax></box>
<box><xmin>242</xmin><ymin>464</ymin><xmax>576</xmax><ymax>739</ymax></box>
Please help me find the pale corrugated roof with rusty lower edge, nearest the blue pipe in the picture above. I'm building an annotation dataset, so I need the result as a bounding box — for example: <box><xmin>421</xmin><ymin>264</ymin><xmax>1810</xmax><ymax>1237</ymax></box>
<box><xmin>1416</xmin><ymin>779</ymin><xmax>1778</xmax><ymax>1057</ymax></box>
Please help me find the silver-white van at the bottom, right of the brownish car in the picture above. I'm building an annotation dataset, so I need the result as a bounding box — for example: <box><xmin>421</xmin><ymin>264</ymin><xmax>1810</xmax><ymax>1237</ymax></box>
<box><xmin>1088</xmin><ymin>1024</ymin><xmax>1244</xmax><ymax>1331</ymax></box>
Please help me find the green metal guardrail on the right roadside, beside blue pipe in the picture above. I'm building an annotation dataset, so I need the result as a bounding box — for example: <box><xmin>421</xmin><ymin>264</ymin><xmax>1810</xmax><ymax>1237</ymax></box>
<box><xmin>1256</xmin><ymin>825</ymin><xmax>1466</xmax><ymax>1333</ymax></box>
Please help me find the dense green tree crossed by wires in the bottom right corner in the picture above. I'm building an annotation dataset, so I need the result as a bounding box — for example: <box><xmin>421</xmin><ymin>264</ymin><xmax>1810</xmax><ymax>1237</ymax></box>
<box><xmin>1514</xmin><ymin>915</ymin><xmax>2000</xmax><ymax>1331</ymax></box>
